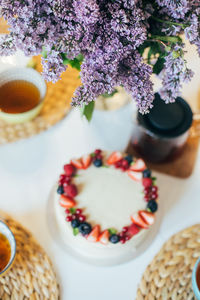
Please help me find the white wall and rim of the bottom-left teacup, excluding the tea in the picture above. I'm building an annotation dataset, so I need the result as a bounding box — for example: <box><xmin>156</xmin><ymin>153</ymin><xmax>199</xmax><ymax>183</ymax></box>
<box><xmin>0</xmin><ymin>220</ymin><xmax>16</xmax><ymax>276</ymax></box>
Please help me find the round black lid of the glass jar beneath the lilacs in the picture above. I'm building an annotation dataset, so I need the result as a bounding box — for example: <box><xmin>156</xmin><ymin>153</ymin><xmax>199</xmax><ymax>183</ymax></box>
<box><xmin>138</xmin><ymin>93</ymin><xmax>193</xmax><ymax>138</ymax></box>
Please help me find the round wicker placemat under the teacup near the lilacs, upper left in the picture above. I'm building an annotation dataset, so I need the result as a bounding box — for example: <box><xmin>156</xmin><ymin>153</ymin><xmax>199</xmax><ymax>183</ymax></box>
<box><xmin>0</xmin><ymin>57</ymin><xmax>80</xmax><ymax>145</ymax></box>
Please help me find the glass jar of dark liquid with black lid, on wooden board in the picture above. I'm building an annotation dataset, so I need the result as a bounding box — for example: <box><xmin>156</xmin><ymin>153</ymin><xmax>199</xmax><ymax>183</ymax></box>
<box><xmin>131</xmin><ymin>93</ymin><xmax>193</xmax><ymax>163</ymax></box>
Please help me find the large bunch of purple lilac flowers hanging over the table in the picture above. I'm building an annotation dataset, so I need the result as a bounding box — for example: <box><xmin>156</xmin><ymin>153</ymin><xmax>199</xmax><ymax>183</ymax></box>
<box><xmin>0</xmin><ymin>0</ymin><xmax>200</xmax><ymax>113</ymax></box>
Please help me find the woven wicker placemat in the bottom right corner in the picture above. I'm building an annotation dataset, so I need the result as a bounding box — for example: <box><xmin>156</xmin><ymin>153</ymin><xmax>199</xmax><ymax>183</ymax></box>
<box><xmin>136</xmin><ymin>224</ymin><xmax>200</xmax><ymax>300</ymax></box>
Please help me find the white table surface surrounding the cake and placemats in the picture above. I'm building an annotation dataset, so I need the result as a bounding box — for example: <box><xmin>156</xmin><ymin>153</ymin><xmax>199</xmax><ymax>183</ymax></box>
<box><xmin>0</xmin><ymin>42</ymin><xmax>200</xmax><ymax>300</ymax></box>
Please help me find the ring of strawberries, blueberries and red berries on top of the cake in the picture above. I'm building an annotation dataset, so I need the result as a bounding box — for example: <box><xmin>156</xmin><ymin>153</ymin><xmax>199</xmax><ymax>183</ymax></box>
<box><xmin>57</xmin><ymin>149</ymin><xmax>158</xmax><ymax>245</ymax></box>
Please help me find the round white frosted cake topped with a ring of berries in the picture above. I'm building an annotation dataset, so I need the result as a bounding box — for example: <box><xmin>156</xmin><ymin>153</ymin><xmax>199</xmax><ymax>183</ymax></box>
<box><xmin>54</xmin><ymin>149</ymin><xmax>158</xmax><ymax>263</ymax></box>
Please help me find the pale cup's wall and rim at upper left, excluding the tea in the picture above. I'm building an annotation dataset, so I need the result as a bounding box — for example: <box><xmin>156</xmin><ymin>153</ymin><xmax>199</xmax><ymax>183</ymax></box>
<box><xmin>0</xmin><ymin>67</ymin><xmax>47</xmax><ymax>124</ymax></box>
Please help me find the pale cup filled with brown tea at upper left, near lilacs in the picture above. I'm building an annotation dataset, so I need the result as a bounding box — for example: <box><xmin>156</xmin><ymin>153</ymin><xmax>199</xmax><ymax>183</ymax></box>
<box><xmin>0</xmin><ymin>67</ymin><xmax>46</xmax><ymax>124</ymax></box>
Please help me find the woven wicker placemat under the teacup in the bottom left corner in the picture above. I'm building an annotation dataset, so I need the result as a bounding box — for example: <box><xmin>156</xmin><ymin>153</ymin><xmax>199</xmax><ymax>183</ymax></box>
<box><xmin>0</xmin><ymin>212</ymin><xmax>59</xmax><ymax>300</ymax></box>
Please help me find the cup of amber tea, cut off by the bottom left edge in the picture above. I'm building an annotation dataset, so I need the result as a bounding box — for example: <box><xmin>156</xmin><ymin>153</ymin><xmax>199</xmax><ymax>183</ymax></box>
<box><xmin>0</xmin><ymin>221</ymin><xmax>16</xmax><ymax>276</ymax></box>
